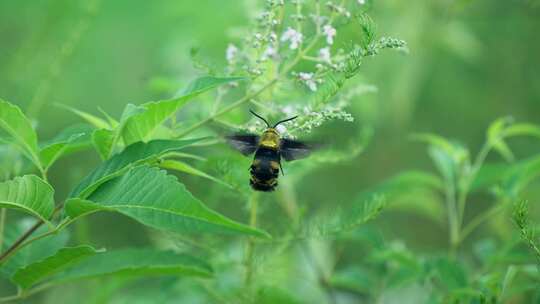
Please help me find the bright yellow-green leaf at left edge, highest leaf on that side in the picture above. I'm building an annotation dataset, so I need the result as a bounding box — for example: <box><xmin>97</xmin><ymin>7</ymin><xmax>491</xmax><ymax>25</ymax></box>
<box><xmin>0</xmin><ymin>99</ymin><xmax>42</xmax><ymax>169</ymax></box>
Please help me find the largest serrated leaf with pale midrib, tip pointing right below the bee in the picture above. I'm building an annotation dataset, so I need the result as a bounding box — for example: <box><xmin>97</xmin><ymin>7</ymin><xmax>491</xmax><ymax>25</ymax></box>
<box><xmin>66</xmin><ymin>166</ymin><xmax>268</xmax><ymax>237</ymax></box>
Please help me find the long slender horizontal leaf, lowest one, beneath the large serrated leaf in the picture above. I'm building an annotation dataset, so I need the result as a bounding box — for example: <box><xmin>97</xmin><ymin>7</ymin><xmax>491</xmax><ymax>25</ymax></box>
<box><xmin>52</xmin><ymin>249</ymin><xmax>212</xmax><ymax>282</ymax></box>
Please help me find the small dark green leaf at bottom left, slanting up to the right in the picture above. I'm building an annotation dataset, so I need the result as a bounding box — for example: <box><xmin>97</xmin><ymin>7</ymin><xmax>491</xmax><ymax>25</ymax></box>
<box><xmin>11</xmin><ymin>246</ymin><xmax>98</xmax><ymax>289</ymax></box>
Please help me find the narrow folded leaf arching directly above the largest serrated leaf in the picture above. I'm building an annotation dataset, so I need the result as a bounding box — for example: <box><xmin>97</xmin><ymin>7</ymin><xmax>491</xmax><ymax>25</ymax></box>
<box><xmin>70</xmin><ymin>138</ymin><xmax>202</xmax><ymax>198</ymax></box>
